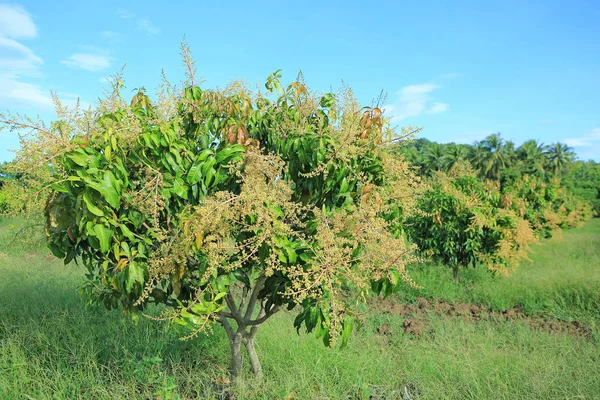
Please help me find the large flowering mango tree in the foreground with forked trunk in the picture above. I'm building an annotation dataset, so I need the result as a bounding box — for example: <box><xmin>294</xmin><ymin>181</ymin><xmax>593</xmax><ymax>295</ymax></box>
<box><xmin>7</xmin><ymin>51</ymin><xmax>420</xmax><ymax>381</ymax></box>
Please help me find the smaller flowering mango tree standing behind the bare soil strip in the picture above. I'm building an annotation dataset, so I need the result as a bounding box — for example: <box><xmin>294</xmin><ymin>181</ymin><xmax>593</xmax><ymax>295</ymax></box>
<box><xmin>408</xmin><ymin>167</ymin><xmax>534</xmax><ymax>279</ymax></box>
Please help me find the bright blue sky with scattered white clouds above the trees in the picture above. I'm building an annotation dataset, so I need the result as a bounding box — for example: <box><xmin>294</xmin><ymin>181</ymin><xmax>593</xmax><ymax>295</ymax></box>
<box><xmin>0</xmin><ymin>0</ymin><xmax>600</xmax><ymax>161</ymax></box>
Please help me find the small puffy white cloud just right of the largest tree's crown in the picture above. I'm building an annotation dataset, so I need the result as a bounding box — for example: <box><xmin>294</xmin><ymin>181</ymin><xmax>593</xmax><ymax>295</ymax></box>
<box><xmin>385</xmin><ymin>83</ymin><xmax>449</xmax><ymax>121</ymax></box>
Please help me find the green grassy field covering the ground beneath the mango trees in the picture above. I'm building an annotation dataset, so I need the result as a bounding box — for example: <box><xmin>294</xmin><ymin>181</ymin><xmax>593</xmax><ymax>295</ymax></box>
<box><xmin>0</xmin><ymin>219</ymin><xmax>600</xmax><ymax>399</ymax></box>
